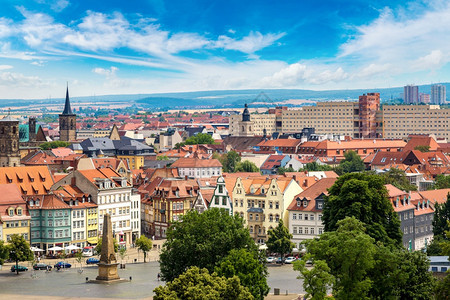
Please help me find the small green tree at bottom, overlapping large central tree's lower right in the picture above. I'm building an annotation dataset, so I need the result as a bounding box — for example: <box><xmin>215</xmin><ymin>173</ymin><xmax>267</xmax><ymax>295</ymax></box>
<box><xmin>215</xmin><ymin>249</ymin><xmax>270</xmax><ymax>300</ymax></box>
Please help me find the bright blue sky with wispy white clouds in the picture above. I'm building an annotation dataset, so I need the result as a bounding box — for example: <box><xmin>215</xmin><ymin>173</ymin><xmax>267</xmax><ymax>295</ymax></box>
<box><xmin>0</xmin><ymin>0</ymin><xmax>450</xmax><ymax>99</ymax></box>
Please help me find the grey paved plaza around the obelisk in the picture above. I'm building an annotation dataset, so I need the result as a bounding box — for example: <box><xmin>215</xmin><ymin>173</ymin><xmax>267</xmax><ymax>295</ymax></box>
<box><xmin>0</xmin><ymin>241</ymin><xmax>303</xmax><ymax>300</ymax></box>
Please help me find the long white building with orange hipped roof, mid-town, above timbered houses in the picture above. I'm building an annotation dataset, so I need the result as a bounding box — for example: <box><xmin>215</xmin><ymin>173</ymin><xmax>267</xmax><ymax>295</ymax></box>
<box><xmin>171</xmin><ymin>157</ymin><xmax>222</xmax><ymax>178</ymax></box>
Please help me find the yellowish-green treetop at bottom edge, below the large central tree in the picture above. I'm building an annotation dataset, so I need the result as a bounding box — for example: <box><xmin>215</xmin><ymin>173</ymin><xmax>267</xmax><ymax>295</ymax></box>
<box><xmin>153</xmin><ymin>267</ymin><xmax>253</xmax><ymax>300</ymax></box>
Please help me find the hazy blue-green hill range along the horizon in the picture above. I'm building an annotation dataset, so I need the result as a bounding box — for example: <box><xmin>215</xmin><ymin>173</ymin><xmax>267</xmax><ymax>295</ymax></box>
<box><xmin>0</xmin><ymin>82</ymin><xmax>450</xmax><ymax>108</ymax></box>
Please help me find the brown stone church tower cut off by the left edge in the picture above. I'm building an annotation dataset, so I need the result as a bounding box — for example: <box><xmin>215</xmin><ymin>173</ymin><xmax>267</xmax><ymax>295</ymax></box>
<box><xmin>0</xmin><ymin>109</ymin><xmax>20</xmax><ymax>167</ymax></box>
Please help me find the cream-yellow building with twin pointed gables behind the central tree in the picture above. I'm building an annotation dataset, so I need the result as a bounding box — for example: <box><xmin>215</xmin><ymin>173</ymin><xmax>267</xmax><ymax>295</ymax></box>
<box><xmin>229</xmin><ymin>176</ymin><xmax>303</xmax><ymax>244</ymax></box>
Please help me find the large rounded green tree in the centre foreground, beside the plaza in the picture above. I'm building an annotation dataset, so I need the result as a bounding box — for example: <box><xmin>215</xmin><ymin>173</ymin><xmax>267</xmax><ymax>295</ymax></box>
<box><xmin>159</xmin><ymin>208</ymin><xmax>258</xmax><ymax>281</ymax></box>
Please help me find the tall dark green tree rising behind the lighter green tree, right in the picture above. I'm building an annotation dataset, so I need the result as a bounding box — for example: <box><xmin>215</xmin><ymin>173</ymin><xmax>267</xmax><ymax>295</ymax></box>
<box><xmin>322</xmin><ymin>173</ymin><xmax>402</xmax><ymax>247</ymax></box>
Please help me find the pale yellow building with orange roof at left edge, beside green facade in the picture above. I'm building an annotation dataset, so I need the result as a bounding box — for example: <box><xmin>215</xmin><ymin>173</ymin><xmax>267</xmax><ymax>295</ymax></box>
<box><xmin>0</xmin><ymin>184</ymin><xmax>31</xmax><ymax>242</ymax></box>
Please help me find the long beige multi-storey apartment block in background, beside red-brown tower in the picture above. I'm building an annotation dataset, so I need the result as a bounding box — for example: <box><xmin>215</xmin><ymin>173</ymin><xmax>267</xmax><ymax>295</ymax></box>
<box><xmin>229</xmin><ymin>96</ymin><xmax>450</xmax><ymax>139</ymax></box>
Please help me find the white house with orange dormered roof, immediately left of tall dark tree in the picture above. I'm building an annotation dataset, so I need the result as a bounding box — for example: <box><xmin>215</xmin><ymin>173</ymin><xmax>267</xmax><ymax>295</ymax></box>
<box><xmin>287</xmin><ymin>178</ymin><xmax>336</xmax><ymax>248</ymax></box>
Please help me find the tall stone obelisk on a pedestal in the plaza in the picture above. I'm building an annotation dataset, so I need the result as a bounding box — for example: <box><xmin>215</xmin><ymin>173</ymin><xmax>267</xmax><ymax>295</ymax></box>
<box><xmin>97</xmin><ymin>214</ymin><xmax>120</xmax><ymax>281</ymax></box>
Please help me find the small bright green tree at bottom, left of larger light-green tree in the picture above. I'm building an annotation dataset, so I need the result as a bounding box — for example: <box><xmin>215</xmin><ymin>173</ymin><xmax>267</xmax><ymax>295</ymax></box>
<box><xmin>294</xmin><ymin>254</ymin><xmax>334</xmax><ymax>300</ymax></box>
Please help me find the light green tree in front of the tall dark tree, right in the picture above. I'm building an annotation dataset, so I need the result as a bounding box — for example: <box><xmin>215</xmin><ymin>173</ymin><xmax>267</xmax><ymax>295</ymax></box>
<box><xmin>305</xmin><ymin>217</ymin><xmax>376</xmax><ymax>299</ymax></box>
